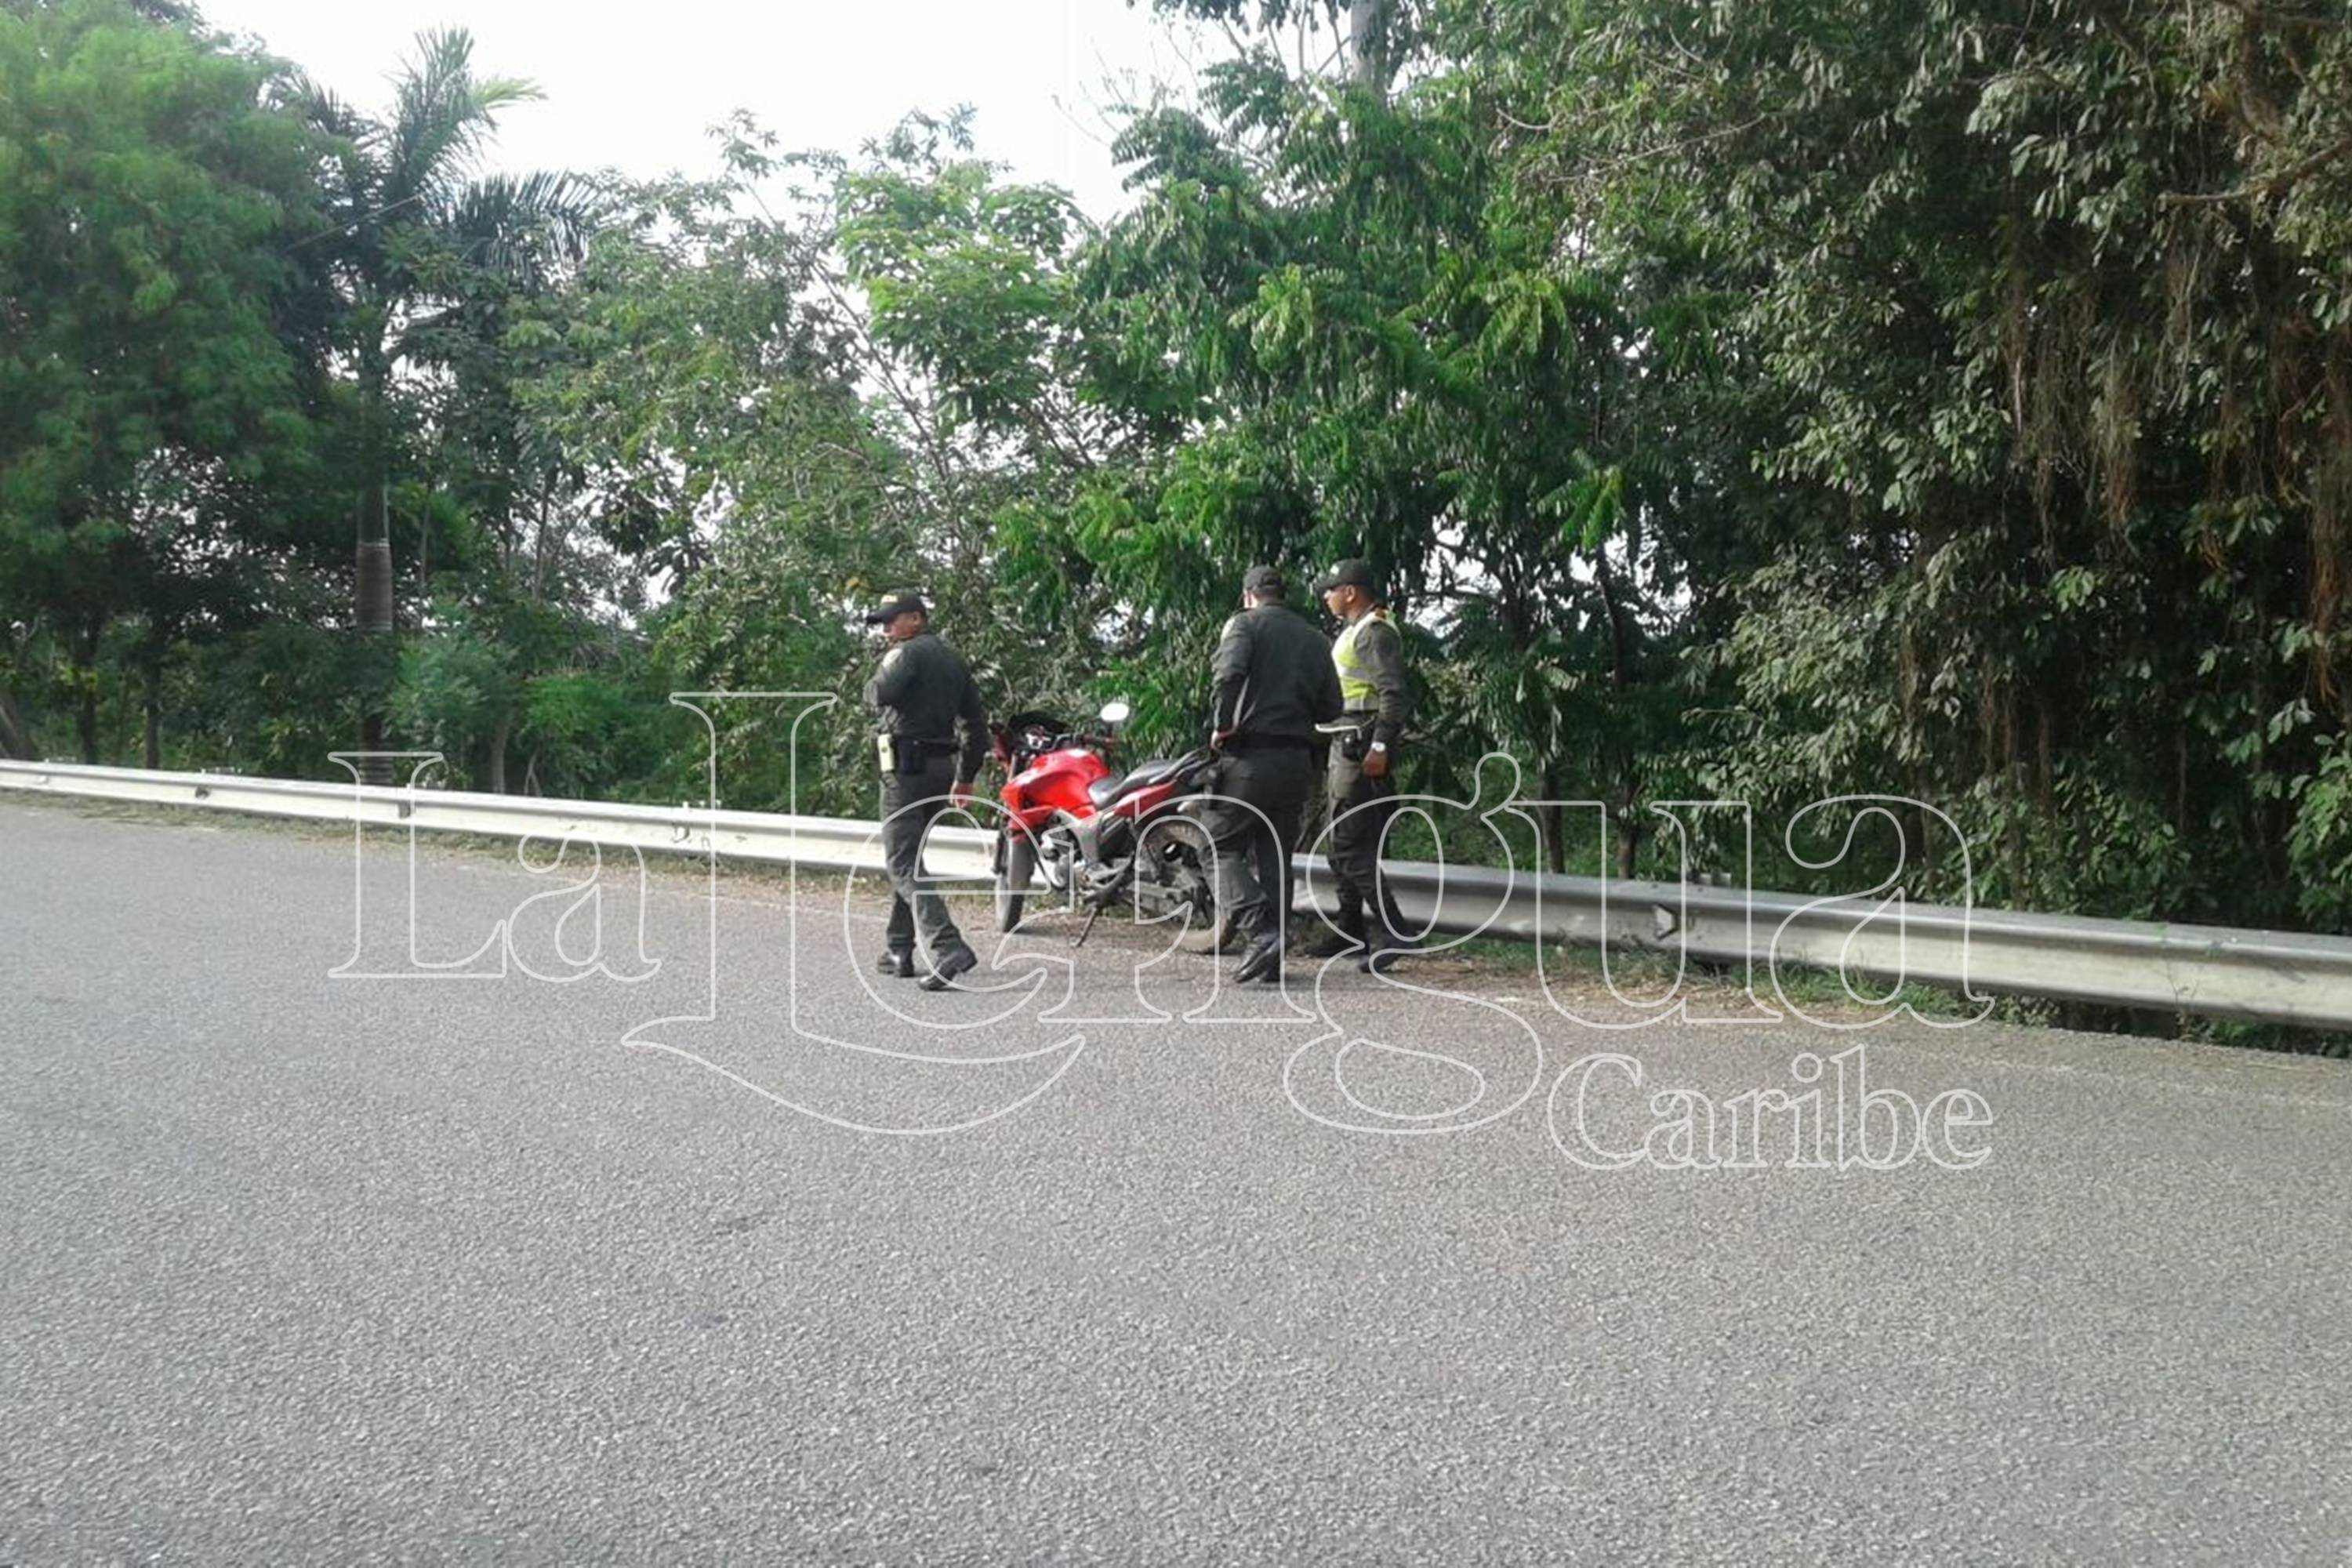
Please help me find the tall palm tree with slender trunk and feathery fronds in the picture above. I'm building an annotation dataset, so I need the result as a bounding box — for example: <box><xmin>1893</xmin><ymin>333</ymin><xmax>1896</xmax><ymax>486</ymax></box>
<box><xmin>289</xmin><ymin>28</ymin><xmax>597</xmax><ymax>783</ymax></box>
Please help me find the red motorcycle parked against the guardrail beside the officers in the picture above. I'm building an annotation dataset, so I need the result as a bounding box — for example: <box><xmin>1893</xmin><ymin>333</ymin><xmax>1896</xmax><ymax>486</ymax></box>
<box><xmin>995</xmin><ymin>701</ymin><xmax>1216</xmax><ymax>942</ymax></box>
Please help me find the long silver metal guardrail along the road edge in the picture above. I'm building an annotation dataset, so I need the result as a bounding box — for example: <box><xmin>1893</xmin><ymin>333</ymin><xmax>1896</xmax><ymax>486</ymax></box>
<box><xmin>13</xmin><ymin>762</ymin><xmax>2352</xmax><ymax>1029</ymax></box>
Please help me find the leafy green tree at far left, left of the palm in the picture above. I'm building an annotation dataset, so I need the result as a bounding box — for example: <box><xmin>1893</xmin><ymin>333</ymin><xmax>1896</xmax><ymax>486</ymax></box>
<box><xmin>0</xmin><ymin>0</ymin><xmax>318</xmax><ymax>762</ymax></box>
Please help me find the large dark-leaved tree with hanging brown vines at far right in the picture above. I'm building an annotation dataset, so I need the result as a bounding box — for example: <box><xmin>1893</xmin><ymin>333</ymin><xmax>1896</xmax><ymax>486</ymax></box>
<box><xmin>1486</xmin><ymin>0</ymin><xmax>2352</xmax><ymax>921</ymax></box>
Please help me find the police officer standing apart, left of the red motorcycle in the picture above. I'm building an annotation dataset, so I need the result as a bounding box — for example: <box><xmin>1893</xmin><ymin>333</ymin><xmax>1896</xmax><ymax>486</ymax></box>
<box><xmin>866</xmin><ymin>590</ymin><xmax>988</xmax><ymax>989</ymax></box>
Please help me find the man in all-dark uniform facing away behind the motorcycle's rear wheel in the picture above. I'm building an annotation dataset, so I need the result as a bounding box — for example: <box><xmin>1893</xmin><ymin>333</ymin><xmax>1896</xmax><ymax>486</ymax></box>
<box><xmin>1204</xmin><ymin>567</ymin><xmax>1341</xmax><ymax>982</ymax></box>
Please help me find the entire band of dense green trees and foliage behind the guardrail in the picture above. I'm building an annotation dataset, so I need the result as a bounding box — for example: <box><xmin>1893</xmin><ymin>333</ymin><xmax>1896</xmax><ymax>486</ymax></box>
<box><xmin>0</xmin><ymin>0</ymin><xmax>2352</xmax><ymax>949</ymax></box>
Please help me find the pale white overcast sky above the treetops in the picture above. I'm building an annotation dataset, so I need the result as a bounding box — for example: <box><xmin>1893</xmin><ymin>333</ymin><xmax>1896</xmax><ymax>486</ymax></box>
<box><xmin>200</xmin><ymin>0</ymin><xmax>1192</xmax><ymax>216</ymax></box>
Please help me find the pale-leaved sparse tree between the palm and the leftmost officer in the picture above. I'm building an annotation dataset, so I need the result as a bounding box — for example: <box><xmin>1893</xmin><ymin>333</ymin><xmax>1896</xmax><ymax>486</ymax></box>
<box><xmin>517</xmin><ymin>120</ymin><xmax>924</xmax><ymax>811</ymax></box>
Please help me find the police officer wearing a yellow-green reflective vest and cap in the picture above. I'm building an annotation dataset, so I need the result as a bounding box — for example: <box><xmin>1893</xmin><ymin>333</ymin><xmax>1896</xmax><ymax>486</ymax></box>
<box><xmin>1305</xmin><ymin>560</ymin><xmax>1418</xmax><ymax>968</ymax></box>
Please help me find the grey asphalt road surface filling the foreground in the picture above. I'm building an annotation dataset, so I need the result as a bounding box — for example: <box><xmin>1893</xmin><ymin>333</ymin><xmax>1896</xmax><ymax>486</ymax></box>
<box><xmin>0</xmin><ymin>804</ymin><xmax>2352</xmax><ymax>1568</ymax></box>
